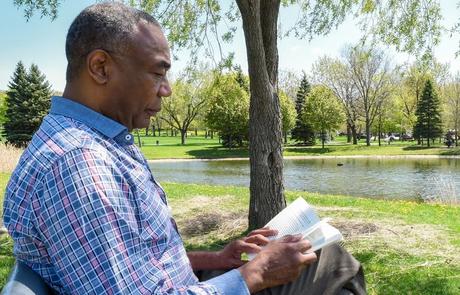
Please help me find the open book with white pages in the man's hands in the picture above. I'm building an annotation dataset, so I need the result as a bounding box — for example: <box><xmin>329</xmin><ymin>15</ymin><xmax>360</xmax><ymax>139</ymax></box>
<box><xmin>248</xmin><ymin>198</ymin><xmax>343</xmax><ymax>260</ymax></box>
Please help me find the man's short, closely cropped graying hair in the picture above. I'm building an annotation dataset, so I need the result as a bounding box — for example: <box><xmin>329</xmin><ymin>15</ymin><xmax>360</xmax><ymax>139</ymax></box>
<box><xmin>65</xmin><ymin>2</ymin><xmax>160</xmax><ymax>82</ymax></box>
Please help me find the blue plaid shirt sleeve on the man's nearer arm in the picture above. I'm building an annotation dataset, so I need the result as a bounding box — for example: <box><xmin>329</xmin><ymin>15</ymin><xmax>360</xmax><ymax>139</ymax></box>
<box><xmin>32</xmin><ymin>149</ymin><xmax>227</xmax><ymax>295</ymax></box>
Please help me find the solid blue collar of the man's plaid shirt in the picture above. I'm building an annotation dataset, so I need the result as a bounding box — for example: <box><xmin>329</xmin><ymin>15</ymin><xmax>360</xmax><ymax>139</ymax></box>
<box><xmin>50</xmin><ymin>96</ymin><xmax>134</xmax><ymax>144</ymax></box>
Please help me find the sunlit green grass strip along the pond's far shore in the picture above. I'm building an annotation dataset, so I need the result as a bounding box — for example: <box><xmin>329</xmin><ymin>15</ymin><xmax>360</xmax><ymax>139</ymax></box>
<box><xmin>136</xmin><ymin>136</ymin><xmax>460</xmax><ymax>159</ymax></box>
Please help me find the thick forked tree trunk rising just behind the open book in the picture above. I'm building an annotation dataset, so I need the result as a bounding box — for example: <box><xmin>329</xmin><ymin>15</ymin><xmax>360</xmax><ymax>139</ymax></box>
<box><xmin>236</xmin><ymin>0</ymin><xmax>286</xmax><ymax>229</ymax></box>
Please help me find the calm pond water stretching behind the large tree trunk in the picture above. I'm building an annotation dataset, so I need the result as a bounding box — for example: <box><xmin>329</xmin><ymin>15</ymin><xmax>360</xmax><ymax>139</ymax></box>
<box><xmin>150</xmin><ymin>157</ymin><xmax>460</xmax><ymax>199</ymax></box>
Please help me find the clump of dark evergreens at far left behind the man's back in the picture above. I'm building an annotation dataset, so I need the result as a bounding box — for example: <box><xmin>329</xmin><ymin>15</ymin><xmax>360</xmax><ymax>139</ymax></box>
<box><xmin>4</xmin><ymin>62</ymin><xmax>51</xmax><ymax>147</ymax></box>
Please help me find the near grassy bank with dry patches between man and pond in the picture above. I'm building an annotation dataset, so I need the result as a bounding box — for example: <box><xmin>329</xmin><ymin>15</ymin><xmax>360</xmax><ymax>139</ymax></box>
<box><xmin>0</xmin><ymin>174</ymin><xmax>460</xmax><ymax>294</ymax></box>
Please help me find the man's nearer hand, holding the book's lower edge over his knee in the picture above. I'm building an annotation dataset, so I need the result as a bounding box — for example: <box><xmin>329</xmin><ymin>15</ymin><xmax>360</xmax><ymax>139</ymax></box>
<box><xmin>239</xmin><ymin>236</ymin><xmax>317</xmax><ymax>293</ymax></box>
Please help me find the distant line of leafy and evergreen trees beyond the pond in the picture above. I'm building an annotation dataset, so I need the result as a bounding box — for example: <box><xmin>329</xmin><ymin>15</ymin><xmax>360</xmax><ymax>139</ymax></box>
<box><xmin>0</xmin><ymin>51</ymin><xmax>460</xmax><ymax>147</ymax></box>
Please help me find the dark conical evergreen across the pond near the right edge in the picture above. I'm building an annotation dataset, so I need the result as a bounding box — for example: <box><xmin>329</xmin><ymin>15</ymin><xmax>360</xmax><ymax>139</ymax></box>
<box><xmin>414</xmin><ymin>79</ymin><xmax>442</xmax><ymax>146</ymax></box>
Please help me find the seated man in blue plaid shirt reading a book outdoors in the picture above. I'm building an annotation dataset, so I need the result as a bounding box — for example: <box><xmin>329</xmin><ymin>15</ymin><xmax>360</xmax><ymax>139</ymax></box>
<box><xmin>4</xmin><ymin>3</ymin><xmax>363</xmax><ymax>294</ymax></box>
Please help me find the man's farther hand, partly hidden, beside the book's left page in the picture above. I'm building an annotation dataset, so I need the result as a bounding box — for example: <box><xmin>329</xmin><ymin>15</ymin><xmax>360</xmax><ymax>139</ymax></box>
<box><xmin>217</xmin><ymin>228</ymin><xmax>277</xmax><ymax>269</ymax></box>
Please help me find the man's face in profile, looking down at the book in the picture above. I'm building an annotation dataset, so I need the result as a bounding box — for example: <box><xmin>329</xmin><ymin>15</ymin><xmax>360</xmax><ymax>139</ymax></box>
<box><xmin>107</xmin><ymin>23</ymin><xmax>171</xmax><ymax>130</ymax></box>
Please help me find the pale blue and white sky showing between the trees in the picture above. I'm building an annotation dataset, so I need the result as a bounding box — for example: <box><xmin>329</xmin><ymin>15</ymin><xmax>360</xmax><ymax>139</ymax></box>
<box><xmin>0</xmin><ymin>0</ymin><xmax>460</xmax><ymax>91</ymax></box>
